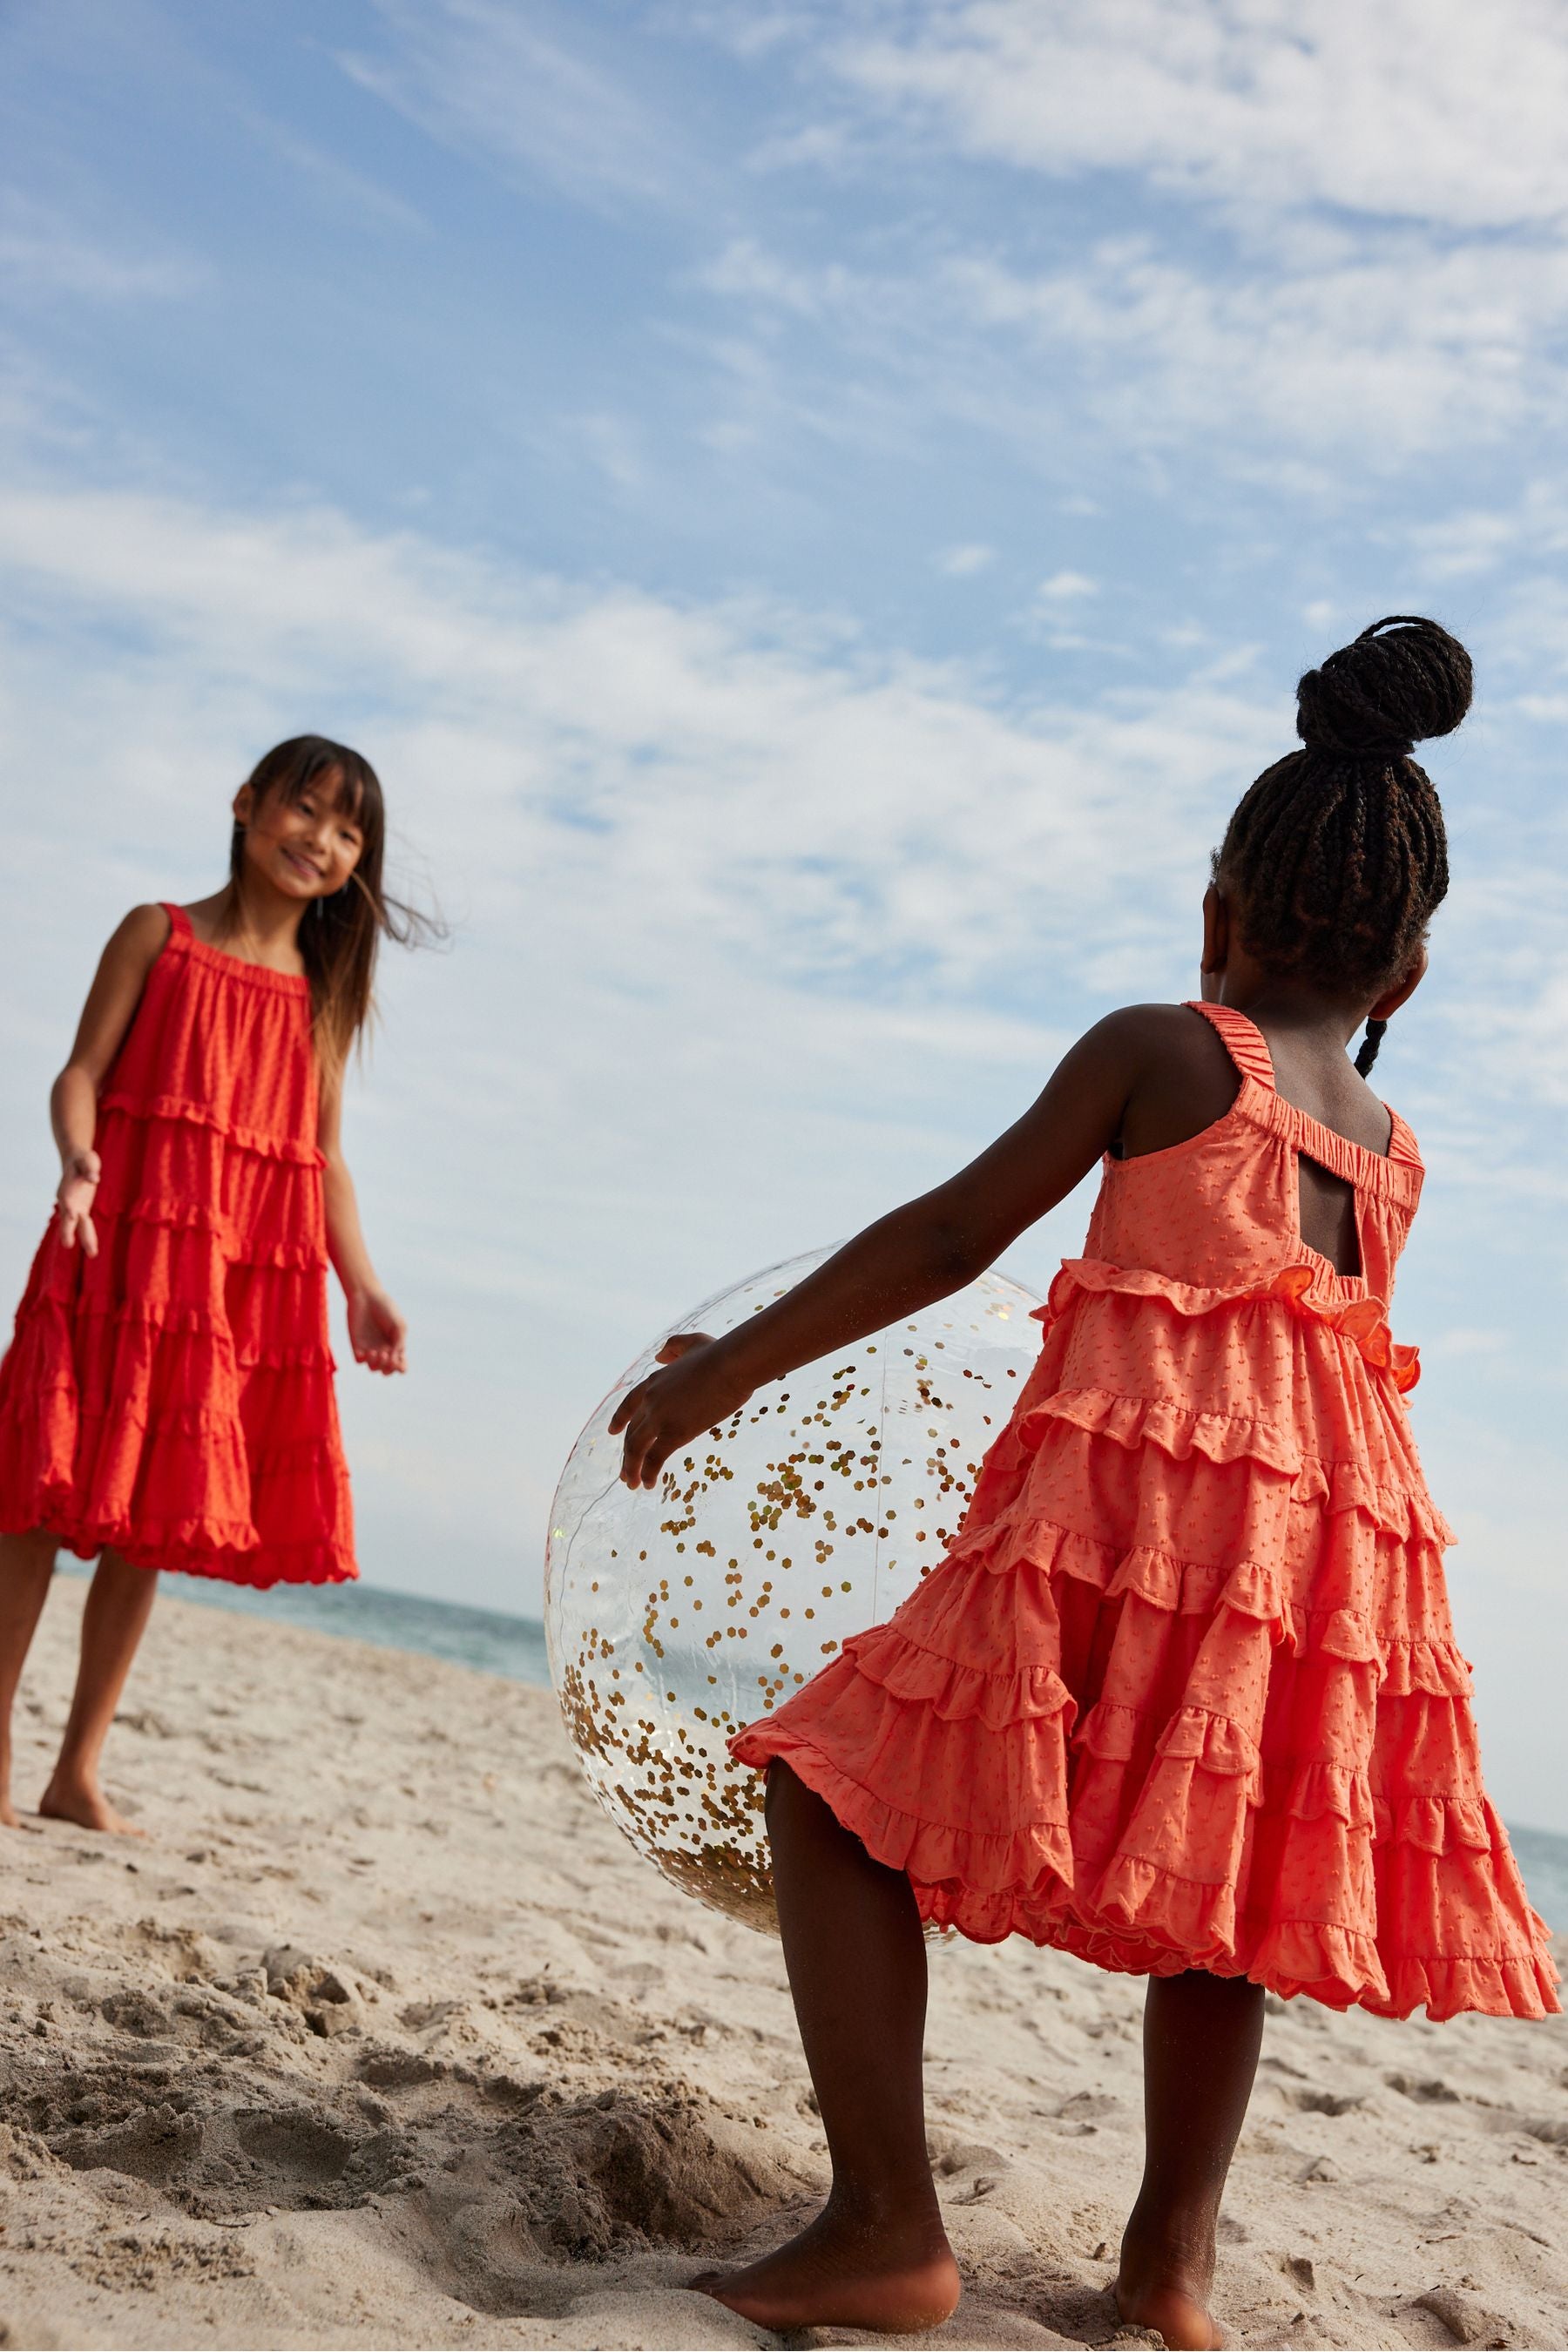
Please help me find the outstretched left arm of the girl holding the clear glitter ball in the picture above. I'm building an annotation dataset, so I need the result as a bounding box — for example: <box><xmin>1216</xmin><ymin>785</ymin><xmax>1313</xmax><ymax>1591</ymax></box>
<box><xmin>609</xmin><ymin>1007</ymin><xmax>1154</xmax><ymax>1486</ymax></box>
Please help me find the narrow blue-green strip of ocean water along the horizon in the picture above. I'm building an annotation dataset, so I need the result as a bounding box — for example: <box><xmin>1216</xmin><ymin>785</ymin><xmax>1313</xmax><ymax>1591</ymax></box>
<box><xmin>67</xmin><ymin>1571</ymin><xmax>1568</xmax><ymax>1936</ymax></box>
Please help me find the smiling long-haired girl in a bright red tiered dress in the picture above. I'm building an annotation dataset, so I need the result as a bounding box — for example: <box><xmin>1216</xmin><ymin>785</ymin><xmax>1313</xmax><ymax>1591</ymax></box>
<box><xmin>0</xmin><ymin>736</ymin><xmax>416</xmax><ymax>1830</ymax></box>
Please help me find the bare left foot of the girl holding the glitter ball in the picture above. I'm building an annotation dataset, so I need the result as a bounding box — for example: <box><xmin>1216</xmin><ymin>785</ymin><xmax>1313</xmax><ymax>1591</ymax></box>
<box><xmin>691</xmin><ymin>2200</ymin><xmax>962</xmax><ymax>2335</ymax></box>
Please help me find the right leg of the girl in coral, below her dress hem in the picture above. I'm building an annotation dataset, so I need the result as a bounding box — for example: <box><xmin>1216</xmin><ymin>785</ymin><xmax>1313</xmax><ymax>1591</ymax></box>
<box><xmin>1117</xmin><ymin>1969</ymin><xmax>1262</xmax><ymax>2352</ymax></box>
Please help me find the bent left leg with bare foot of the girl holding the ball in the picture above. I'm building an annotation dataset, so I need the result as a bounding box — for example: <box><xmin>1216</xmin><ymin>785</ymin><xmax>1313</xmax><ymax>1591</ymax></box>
<box><xmin>696</xmin><ymin>1764</ymin><xmax>959</xmax><ymax>2333</ymax></box>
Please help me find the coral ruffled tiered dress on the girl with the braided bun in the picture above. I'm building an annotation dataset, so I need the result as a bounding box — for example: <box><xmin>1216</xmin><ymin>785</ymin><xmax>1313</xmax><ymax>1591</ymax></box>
<box><xmin>731</xmin><ymin>1004</ymin><xmax>1558</xmax><ymax>2018</ymax></box>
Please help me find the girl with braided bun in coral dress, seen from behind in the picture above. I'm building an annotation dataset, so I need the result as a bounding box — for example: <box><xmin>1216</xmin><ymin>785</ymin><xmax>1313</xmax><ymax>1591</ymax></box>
<box><xmin>616</xmin><ymin>618</ymin><xmax>1558</xmax><ymax>2345</ymax></box>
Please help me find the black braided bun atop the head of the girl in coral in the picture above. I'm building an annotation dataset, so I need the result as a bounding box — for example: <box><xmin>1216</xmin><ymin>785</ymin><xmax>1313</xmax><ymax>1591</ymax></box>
<box><xmin>1295</xmin><ymin>612</ymin><xmax>1471</xmax><ymax>760</ymax></box>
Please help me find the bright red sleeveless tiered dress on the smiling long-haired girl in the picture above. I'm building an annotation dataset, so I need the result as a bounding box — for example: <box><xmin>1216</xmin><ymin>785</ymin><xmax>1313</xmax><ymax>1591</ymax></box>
<box><xmin>0</xmin><ymin>906</ymin><xmax>357</xmax><ymax>1585</ymax></box>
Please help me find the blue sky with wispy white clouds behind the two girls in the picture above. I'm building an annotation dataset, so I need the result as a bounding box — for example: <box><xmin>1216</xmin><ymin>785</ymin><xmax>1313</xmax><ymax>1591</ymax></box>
<box><xmin>0</xmin><ymin>0</ymin><xmax>1568</xmax><ymax>1830</ymax></box>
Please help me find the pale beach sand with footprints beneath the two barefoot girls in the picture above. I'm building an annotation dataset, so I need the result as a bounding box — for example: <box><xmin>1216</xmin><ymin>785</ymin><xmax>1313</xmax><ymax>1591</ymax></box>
<box><xmin>0</xmin><ymin>1578</ymin><xmax>1568</xmax><ymax>2348</ymax></box>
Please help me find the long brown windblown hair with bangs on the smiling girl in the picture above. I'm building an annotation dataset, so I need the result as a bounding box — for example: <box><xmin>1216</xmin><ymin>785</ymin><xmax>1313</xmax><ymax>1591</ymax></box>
<box><xmin>228</xmin><ymin>736</ymin><xmax>442</xmax><ymax>1071</ymax></box>
